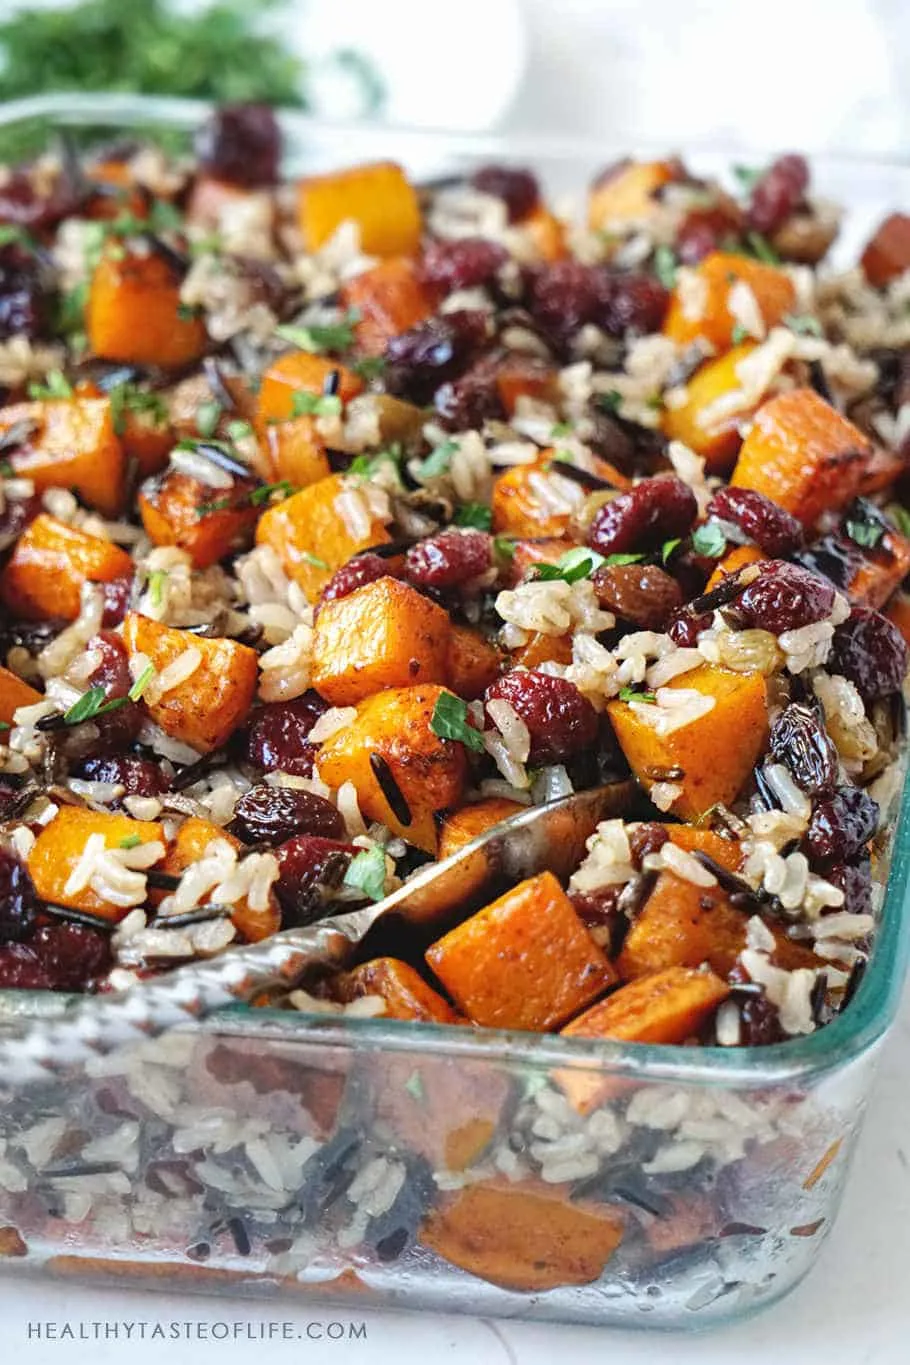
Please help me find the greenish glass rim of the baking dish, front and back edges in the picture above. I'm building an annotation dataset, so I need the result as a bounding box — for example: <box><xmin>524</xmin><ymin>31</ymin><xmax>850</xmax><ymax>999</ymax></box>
<box><xmin>0</xmin><ymin>85</ymin><xmax>910</xmax><ymax>1088</ymax></box>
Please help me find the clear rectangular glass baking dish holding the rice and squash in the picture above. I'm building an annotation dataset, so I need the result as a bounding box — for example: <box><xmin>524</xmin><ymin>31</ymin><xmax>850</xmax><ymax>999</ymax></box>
<box><xmin>0</xmin><ymin>96</ymin><xmax>910</xmax><ymax>1328</ymax></box>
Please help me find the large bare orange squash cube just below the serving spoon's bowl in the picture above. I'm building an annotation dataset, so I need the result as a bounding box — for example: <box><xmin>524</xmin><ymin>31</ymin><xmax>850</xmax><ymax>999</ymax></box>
<box><xmin>426</xmin><ymin>872</ymin><xmax>617</xmax><ymax>1032</ymax></box>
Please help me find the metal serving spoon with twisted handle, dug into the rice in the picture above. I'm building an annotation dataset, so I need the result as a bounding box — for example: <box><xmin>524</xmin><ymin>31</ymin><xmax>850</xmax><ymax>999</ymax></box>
<box><xmin>0</xmin><ymin>781</ymin><xmax>637</xmax><ymax>1088</ymax></box>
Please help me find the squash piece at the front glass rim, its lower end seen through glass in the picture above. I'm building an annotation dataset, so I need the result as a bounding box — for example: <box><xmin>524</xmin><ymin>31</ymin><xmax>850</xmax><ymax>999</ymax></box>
<box><xmin>554</xmin><ymin>966</ymin><xmax>730</xmax><ymax>1114</ymax></box>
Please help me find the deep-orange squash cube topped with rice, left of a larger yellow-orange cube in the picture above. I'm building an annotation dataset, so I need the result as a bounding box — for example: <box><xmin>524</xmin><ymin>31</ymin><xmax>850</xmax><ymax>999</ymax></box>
<box><xmin>138</xmin><ymin>470</ymin><xmax>259</xmax><ymax>569</ymax></box>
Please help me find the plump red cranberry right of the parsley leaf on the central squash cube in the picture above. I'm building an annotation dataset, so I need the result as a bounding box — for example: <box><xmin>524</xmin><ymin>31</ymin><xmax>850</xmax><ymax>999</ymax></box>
<box><xmin>486</xmin><ymin>669</ymin><xmax>598</xmax><ymax>763</ymax></box>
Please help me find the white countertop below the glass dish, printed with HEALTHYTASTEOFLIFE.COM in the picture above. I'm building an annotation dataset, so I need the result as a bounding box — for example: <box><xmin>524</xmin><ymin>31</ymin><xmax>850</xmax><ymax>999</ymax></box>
<box><xmin>0</xmin><ymin>992</ymin><xmax>910</xmax><ymax>1365</ymax></box>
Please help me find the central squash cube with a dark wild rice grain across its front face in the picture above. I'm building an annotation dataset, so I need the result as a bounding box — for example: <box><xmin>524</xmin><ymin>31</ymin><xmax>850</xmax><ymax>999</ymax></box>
<box><xmin>317</xmin><ymin>684</ymin><xmax>468</xmax><ymax>853</ymax></box>
